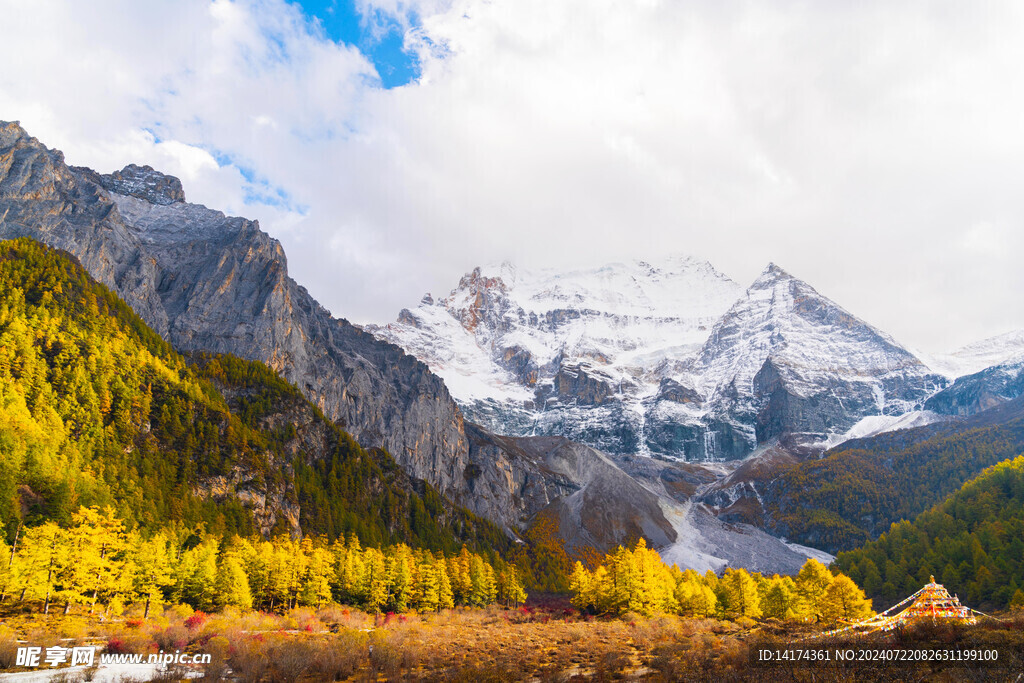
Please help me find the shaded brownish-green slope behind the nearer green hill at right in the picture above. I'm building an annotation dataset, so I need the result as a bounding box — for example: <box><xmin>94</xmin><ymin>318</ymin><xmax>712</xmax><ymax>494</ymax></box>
<box><xmin>763</xmin><ymin>399</ymin><xmax>1024</xmax><ymax>552</ymax></box>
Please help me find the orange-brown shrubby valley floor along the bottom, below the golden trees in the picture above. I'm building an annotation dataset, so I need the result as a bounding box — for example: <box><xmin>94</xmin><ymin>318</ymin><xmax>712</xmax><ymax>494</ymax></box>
<box><xmin>0</xmin><ymin>600</ymin><xmax>1024</xmax><ymax>683</ymax></box>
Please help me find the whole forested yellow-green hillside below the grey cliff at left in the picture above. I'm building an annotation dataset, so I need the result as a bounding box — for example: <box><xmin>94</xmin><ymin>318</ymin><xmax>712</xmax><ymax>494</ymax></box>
<box><xmin>0</xmin><ymin>239</ymin><xmax>508</xmax><ymax>549</ymax></box>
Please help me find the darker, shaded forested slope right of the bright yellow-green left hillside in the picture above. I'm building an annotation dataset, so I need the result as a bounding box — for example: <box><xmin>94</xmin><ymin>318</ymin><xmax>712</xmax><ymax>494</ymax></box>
<box><xmin>191</xmin><ymin>354</ymin><xmax>511</xmax><ymax>551</ymax></box>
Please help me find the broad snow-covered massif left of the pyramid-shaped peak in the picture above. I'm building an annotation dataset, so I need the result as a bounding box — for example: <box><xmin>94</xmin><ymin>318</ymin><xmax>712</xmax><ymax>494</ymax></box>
<box><xmin>370</xmin><ymin>256</ymin><xmax>740</xmax><ymax>457</ymax></box>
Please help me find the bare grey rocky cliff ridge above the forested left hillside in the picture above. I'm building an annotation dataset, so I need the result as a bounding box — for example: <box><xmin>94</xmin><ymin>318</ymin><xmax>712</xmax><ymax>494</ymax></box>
<box><xmin>0</xmin><ymin>123</ymin><xmax>471</xmax><ymax>503</ymax></box>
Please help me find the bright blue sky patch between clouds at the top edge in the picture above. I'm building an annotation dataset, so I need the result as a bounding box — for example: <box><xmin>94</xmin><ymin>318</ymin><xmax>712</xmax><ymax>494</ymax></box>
<box><xmin>298</xmin><ymin>0</ymin><xmax>420</xmax><ymax>88</ymax></box>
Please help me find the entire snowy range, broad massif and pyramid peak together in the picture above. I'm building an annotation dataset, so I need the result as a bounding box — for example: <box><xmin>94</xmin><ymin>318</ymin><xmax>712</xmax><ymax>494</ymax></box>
<box><xmin>371</xmin><ymin>257</ymin><xmax>946</xmax><ymax>461</ymax></box>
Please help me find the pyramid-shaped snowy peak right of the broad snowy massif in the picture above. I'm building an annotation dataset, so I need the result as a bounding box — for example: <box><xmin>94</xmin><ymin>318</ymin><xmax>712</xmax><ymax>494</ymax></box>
<box><xmin>692</xmin><ymin>264</ymin><xmax>945</xmax><ymax>455</ymax></box>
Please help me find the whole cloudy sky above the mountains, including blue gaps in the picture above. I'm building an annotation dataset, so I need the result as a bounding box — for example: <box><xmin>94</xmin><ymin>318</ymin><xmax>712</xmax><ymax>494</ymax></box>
<box><xmin>0</xmin><ymin>0</ymin><xmax>1024</xmax><ymax>352</ymax></box>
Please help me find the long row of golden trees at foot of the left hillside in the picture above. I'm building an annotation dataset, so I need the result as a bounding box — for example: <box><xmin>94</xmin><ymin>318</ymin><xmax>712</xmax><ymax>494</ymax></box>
<box><xmin>0</xmin><ymin>507</ymin><xmax>526</xmax><ymax>615</ymax></box>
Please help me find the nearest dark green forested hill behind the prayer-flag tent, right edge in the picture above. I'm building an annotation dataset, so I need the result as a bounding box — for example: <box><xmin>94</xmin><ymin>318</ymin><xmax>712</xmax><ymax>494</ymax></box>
<box><xmin>836</xmin><ymin>456</ymin><xmax>1024</xmax><ymax>609</ymax></box>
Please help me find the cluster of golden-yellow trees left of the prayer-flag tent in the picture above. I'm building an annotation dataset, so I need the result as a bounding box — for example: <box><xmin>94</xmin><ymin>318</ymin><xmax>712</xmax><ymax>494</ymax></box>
<box><xmin>569</xmin><ymin>539</ymin><xmax>871</xmax><ymax>624</ymax></box>
